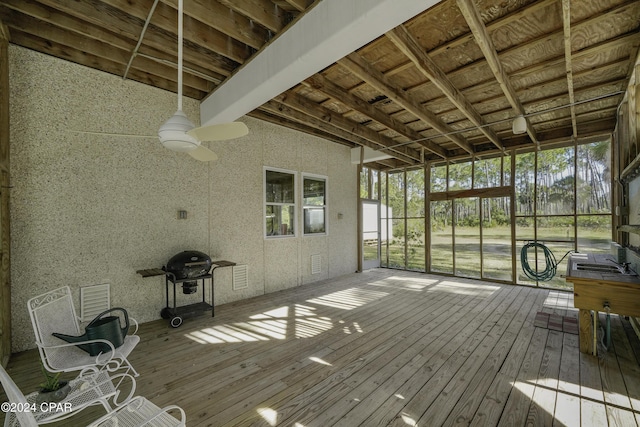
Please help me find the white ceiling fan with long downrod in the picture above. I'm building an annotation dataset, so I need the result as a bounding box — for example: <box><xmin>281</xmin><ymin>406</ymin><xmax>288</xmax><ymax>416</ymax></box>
<box><xmin>73</xmin><ymin>0</ymin><xmax>249</xmax><ymax>162</ymax></box>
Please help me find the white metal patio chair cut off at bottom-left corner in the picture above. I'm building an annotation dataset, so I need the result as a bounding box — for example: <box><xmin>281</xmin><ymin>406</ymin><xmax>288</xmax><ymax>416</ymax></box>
<box><xmin>0</xmin><ymin>365</ymin><xmax>186</xmax><ymax>427</ymax></box>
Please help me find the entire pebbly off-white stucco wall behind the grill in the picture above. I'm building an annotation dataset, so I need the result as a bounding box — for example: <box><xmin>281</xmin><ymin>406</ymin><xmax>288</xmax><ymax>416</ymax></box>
<box><xmin>9</xmin><ymin>46</ymin><xmax>357</xmax><ymax>351</ymax></box>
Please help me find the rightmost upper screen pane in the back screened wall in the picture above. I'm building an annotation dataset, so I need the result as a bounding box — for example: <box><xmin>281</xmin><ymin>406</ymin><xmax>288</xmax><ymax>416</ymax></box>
<box><xmin>577</xmin><ymin>141</ymin><xmax>611</xmax><ymax>214</ymax></box>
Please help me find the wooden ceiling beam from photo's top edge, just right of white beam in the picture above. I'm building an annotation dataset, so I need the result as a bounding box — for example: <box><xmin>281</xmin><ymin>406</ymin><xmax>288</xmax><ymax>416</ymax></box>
<box><xmin>456</xmin><ymin>0</ymin><xmax>539</xmax><ymax>145</ymax></box>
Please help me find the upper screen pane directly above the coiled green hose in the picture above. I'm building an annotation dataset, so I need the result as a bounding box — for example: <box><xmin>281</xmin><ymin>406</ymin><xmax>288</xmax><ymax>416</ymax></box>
<box><xmin>536</xmin><ymin>147</ymin><xmax>575</xmax><ymax>215</ymax></box>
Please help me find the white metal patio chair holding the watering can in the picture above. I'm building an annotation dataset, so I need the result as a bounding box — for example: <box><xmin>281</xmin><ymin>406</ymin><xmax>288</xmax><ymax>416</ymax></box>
<box><xmin>27</xmin><ymin>286</ymin><xmax>140</xmax><ymax>376</ymax></box>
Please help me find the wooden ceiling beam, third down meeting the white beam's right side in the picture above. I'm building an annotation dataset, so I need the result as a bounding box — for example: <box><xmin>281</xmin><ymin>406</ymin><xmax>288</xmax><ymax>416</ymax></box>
<box><xmin>303</xmin><ymin>74</ymin><xmax>448</xmax><ymax>159</ymax></box>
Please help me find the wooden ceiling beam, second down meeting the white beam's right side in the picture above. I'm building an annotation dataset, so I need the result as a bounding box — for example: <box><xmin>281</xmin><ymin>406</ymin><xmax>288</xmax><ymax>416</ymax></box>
<box><xmin>338</xmin><ymin>52</ymin><xmax>473</xmax><ymax>154</ymax></box>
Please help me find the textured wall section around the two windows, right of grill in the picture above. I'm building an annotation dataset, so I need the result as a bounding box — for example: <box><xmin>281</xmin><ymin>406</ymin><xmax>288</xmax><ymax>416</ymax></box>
<box><xmin>210</xmin><ymin>117</ymin><xmax>357</xmax><ymax>303</ymax></box>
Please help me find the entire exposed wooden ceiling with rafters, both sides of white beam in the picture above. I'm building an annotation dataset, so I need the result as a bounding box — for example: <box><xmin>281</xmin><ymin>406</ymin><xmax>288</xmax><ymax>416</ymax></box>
<box><xmin>0</xmin><ymin>0</ymin><xmax>640</xmax><ymax>164</ymax></box>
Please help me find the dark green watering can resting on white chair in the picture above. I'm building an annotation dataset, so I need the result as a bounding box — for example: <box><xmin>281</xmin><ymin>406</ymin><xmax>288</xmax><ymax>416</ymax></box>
<box><xmin>52</xmin><ymin>307</ymin><xmax>129</xmax><ymax>356</ymax></box>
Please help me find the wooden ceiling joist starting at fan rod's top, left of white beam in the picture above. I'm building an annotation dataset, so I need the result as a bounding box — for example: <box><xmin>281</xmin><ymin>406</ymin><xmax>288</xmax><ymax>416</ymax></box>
<box><xmin>161</xmin><ymin>0</ymin><xmax>269</xmax><ymax>49</ymax></box>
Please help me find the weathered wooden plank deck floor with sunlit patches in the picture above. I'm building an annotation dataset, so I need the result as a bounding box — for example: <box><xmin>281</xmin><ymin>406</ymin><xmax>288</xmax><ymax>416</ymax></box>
<box><xmin>1</xmin><ymin>269</ymin><xmax>640</xmax><ymax>427</ymax></box>
